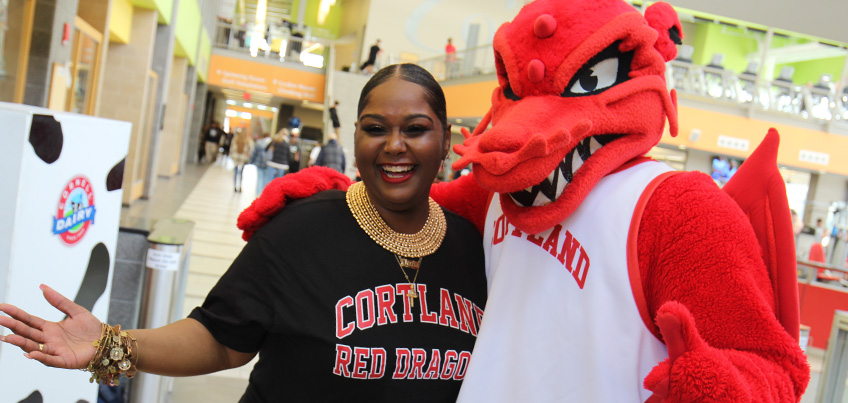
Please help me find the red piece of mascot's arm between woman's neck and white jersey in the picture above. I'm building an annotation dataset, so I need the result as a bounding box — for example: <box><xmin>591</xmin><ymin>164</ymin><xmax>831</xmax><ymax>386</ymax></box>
<box><xmin>430</xmin><ymin>173</ymin><xmax>491</xmax><ymax>234</ymax></box>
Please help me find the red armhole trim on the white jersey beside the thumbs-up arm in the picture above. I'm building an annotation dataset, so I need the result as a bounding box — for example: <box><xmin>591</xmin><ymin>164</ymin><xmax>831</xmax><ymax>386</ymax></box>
<box><xmin>627</xmin><ymin>170</ymin><xmax>681</xmax><ymax>341</ymax></box>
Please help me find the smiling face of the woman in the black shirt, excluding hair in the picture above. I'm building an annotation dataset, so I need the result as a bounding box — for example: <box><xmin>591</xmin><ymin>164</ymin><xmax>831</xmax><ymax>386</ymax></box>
<box><xmin>354</xmin><ymin>77</ymin><xmax>450</xmax><ymax>211</ymax></box>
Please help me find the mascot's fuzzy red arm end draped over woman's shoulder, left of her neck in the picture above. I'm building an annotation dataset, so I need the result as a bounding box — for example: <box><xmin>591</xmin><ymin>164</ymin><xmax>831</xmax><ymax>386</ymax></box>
<box><xmin>237</xmin><ymin>166</ymin><xmax>352</xmax><ymax>241</ymax></box>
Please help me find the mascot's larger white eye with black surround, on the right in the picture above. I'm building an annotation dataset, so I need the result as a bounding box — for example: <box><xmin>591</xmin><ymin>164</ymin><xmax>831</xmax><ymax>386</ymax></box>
<box><xmin>562</xmin><ymin>42</ymin><xmax>633</xmax><ymax>97</ymax></box>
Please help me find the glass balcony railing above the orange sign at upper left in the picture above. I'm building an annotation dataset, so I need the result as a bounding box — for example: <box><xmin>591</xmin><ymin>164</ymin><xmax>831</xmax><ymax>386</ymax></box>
<box><xmin>213</xmin><ymin>21</ymin><xmax>327</xmax><ymax>69</ymax></box>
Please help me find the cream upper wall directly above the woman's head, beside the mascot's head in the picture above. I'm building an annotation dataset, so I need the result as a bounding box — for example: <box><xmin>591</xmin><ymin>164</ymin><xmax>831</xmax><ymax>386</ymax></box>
<box><xmin>360</xmin><ymin>0</ymin><xmax>524</xmax><ymax>67</ymax></box>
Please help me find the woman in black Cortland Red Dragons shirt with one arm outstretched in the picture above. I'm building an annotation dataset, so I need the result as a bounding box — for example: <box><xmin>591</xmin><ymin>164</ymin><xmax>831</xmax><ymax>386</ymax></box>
<box><xmin>0</xmin><ymin>64</ymin><xmax>486</xmax><ymax>403</ymax></box>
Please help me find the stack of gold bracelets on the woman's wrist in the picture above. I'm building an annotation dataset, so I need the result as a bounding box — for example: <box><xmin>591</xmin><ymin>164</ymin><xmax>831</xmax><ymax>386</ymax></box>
<box><xmin>83</xmin><ymin>323</ymin><xmax>138</xmax><ymax>386</ymax></box>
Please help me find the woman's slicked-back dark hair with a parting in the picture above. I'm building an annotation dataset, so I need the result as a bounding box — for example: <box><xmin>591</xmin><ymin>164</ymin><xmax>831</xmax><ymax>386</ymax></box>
<box><xmin>356</xmin><ymin>63</ymin><xmax>448</xmax><ymax>129</ymax></box>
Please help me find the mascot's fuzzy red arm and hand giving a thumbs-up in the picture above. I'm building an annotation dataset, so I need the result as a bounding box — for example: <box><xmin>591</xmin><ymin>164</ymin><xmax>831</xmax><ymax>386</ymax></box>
<box><xmin>637</xmin><ymin>172</ymin><xmax>810</xmax><ymax>403</ymax></box>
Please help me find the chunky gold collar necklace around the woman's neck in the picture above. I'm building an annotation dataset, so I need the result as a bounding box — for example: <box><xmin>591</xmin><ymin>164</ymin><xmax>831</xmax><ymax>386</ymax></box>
<box><xmin>346</xmin><ymin>182</ymin><xmax>447</xmax><ymax>258</ymax></box>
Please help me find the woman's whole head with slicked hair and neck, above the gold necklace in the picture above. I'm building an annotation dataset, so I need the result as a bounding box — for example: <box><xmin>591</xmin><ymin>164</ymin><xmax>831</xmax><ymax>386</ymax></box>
<box><xmin>354</xmin><ymin>64</ymin><xmax>450</xmax><ymax>233</ymax></box>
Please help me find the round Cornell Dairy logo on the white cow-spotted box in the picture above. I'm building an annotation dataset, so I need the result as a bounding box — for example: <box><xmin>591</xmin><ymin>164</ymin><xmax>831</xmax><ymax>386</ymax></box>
<box><xmin>53</xmin><ymin>175</ymin><xmax>96</xmax><ymax>245</ymax></box>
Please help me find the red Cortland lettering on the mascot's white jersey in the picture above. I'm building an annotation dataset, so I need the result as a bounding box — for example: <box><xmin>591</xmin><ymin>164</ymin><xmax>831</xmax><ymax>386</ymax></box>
<box><xmin>492</xmin><ymin>214</ymin><xmax>589</xmax><ymax>289</ymax></box>
